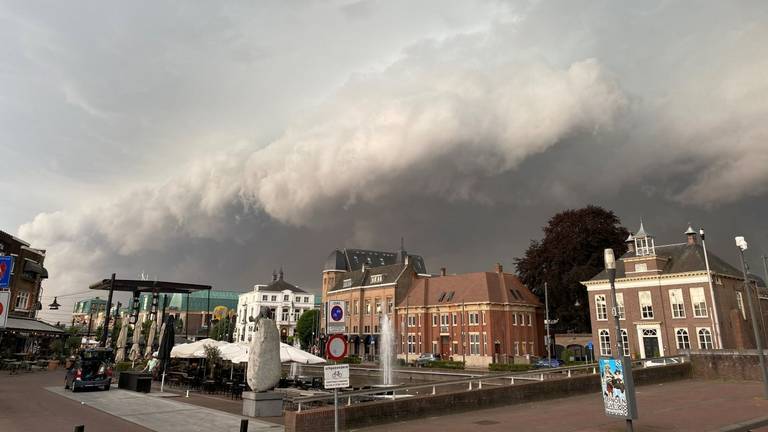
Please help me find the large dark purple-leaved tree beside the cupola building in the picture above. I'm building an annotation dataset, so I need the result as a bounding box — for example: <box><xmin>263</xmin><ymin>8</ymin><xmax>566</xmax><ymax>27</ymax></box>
<box><xmin>515</xmin><ymin>205</ymin><xmax>629</xmax><ymax>332</ymax></box>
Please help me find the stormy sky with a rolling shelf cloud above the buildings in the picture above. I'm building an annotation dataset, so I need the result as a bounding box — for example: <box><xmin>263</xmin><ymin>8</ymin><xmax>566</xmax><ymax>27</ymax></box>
<box><xmin>0</xmin><ymin>0</ymin><xmax>768</xmax><ymax>321</ymax></box>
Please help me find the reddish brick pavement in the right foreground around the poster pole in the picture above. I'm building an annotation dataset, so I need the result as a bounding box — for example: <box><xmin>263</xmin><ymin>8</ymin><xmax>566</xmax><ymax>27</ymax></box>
<box><xmin>352</xmin><ymin>380</ymin><xmax>768</xmax><ymax>432</ymax></box>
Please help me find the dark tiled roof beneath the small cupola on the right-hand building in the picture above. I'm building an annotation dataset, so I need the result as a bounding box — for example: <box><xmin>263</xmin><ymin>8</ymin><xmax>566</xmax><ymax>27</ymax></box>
<box><xmin>590</xmin><ymin>243</ymin><xmax>762</xmax><ymax>283</ymax></box>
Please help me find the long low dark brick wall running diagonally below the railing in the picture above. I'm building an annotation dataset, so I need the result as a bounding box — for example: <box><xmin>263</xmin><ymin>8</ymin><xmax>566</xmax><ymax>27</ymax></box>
<box><xmin>284</xmin><ymin>363</ymin><xmax>691</xmax><ymax>432</ymax></box>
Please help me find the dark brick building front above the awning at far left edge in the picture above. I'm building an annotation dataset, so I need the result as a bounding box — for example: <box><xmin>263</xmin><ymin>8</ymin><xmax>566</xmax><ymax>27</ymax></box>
<box><xmin>0</xmin><ymin>231</ymin><xmax>48</xmax><ymax>318</ymax></box>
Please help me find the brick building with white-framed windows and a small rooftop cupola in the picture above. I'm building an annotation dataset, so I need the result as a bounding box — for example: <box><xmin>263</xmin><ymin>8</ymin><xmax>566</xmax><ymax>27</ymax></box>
<box><xmin>582</xmin><ymin>223</ymin><xmax>766</xmax><ymax>358</ymax></box>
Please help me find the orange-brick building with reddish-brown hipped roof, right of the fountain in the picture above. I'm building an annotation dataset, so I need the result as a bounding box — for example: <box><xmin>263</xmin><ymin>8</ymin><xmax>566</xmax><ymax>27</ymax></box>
<box><xmin>396</xmin><ymin>264</ymin><xmax>544</xmax><ymax>367</ymax></box>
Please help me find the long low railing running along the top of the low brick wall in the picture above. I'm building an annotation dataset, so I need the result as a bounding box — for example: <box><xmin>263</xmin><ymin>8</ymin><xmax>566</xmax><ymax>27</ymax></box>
<box><xmin>283</xmin><ymin>356</ymin><xmax>686</xmax><ymax>411</ymax></box>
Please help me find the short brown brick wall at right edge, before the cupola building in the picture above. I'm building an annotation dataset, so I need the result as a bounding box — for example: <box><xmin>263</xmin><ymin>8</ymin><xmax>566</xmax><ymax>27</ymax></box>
<box><xmin>690</xmin><ymin>350</ymin><xmax>768</xmax><ymax>381</ymax></box>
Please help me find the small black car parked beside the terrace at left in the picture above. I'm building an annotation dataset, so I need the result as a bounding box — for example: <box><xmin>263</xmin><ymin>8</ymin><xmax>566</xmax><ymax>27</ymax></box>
<box><xmin>64</xmin><ymin>348</ymin><xmax>115</xmax><ymax>392</ymax></box>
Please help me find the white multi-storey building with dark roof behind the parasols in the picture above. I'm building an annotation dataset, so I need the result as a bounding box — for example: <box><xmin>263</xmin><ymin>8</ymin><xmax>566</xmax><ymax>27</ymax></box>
<box><xmin>234</xmin><ymin>270</ymin><xmax>315</xmax><ymax>342</ymax></box>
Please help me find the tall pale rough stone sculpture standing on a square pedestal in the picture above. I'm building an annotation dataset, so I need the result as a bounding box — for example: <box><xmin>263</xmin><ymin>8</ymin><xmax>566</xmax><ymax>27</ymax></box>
<box><xmin>248</xmin><ymin>308</ymin><xmax>282</xmax><ymax>392</ymax></box>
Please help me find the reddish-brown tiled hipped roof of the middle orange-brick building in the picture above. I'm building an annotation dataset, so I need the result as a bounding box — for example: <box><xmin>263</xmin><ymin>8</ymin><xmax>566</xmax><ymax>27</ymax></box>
<box><xmin>398</xmin><ymin>272</ymin><xmax>541</xmax><ymax>306</ymax></box>
